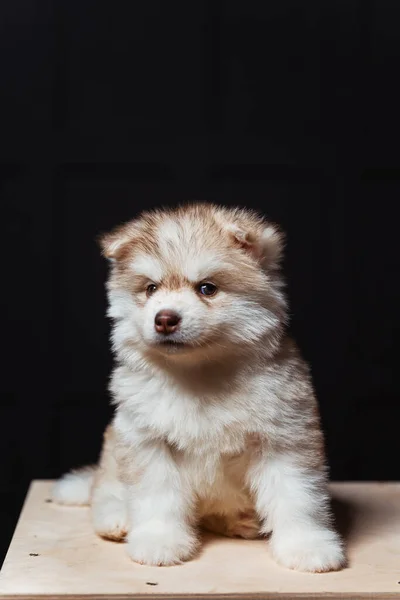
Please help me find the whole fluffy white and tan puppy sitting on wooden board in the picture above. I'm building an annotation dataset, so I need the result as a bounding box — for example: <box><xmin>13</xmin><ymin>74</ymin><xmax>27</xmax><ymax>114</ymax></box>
<box><xmin>54</xmin><ymin>204</ymin><xmax>345</xmax><ymax>572</ymax></box>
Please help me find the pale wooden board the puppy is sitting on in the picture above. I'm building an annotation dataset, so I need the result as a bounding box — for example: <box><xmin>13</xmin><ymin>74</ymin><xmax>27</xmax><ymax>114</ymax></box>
<box><xmin>0</xmin><ymin>481</ymin><xmax>400</xmax><ymax>600</ymax></box>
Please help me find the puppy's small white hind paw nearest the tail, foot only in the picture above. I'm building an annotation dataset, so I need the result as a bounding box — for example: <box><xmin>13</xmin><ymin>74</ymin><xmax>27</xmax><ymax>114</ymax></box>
<box><xmin>92</xmin><ymin>498</ymin><xmax>128</xmax><ymax>542</ymax></box>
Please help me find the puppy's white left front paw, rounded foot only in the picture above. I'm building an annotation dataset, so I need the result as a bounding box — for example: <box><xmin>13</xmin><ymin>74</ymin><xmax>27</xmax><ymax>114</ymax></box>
<box><xmin>128</xmin><ymin>521</ymin><xmax>198</xmax><ymax>566</ymax></box>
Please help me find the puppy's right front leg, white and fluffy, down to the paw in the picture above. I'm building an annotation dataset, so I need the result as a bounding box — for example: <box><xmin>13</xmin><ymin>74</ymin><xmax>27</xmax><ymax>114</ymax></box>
<box><xmin>249</xmin><ymin>452</ymin><xmax>346</xmax><ymax>572</ymax></box>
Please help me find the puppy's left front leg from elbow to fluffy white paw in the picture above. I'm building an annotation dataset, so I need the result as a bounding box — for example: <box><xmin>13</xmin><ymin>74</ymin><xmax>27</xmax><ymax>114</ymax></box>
<box><xmin>120</xmin><ymin>440</ymin><xmax>198</xmax><ymax>565</ymax></box>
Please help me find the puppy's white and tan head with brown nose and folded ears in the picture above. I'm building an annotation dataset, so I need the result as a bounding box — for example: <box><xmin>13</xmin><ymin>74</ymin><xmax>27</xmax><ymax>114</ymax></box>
<box><xmin>101</xmin><ymin>204</ymin><xmax>286</xmax><ymax>360</ymax></box>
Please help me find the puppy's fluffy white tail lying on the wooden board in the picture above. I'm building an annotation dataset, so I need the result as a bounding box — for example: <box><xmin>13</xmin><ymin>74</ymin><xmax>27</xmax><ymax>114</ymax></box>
<box><xmin>51</xmin><ymin>466</ymin><xmax>97</xmax><ymax>506</ymax></box>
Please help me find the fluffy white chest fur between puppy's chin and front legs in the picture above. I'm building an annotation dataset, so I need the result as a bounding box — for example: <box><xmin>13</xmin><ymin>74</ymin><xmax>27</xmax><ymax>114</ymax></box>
<box><xmin>112</xmin><ymin>367</ymin><xmax>266</xmax><ymax>456</ymax></box>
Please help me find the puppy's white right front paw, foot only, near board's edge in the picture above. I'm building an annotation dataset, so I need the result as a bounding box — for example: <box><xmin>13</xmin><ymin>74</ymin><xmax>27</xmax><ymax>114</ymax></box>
<box><xmin>271</xmin><ymin>529</ymin><xmax>346</xmax><ymax>573</ymax></box>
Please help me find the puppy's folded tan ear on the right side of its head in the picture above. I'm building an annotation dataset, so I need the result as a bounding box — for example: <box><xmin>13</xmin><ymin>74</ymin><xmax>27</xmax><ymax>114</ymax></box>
<box><xmin>229</xmin><ymin>223</ymin><xmax>284</xmax><ymax>269</ymax></box>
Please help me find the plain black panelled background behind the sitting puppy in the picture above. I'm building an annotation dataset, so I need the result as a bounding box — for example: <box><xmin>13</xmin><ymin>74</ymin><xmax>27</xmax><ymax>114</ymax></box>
<box><xmin>0</xmin><ymin>0</ymin><xmax>400</xmax><ymax>564</ymax></box>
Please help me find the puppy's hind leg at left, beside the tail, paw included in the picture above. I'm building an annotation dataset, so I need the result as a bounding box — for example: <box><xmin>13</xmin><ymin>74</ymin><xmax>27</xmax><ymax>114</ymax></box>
<box><xmin>92</xmin><ymin>425</ymin><xmax>128</xmax><ymax>541</ymax></box>
